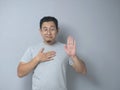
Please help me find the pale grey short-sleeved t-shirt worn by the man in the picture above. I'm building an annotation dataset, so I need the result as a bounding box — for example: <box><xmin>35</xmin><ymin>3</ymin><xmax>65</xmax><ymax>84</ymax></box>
<box><xmin>21</xmin><ymin>42</ymin><xmax>73</xmax><ymax>90</ymax></box>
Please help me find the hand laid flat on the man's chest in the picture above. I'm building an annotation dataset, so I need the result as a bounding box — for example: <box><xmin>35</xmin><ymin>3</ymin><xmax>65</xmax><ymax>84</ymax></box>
<box><xmin>36</xmin><ymin>48</ymin><xmax>56</xmax><ymax>62</ymax></box>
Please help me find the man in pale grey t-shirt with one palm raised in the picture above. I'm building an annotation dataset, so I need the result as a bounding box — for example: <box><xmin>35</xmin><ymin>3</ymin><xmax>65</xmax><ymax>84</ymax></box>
<box><xmin>18</xmin><ymin>16</ymin><xmax>86</xmax><ymax>90</ymax></box>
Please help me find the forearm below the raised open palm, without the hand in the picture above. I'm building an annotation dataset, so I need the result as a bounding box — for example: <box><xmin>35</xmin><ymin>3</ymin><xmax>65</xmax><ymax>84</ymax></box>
<box><xmin>71</xmin><ymin>56</ymin><xmax>87</xmax><ymax>74</ymax></box>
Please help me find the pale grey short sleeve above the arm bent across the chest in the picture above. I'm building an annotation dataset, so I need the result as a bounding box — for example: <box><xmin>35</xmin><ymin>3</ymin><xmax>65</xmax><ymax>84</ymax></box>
<box><xmin>21</xmin><ymin>47</ymin><xmax>32</xmax><ymax>62</ymax></box>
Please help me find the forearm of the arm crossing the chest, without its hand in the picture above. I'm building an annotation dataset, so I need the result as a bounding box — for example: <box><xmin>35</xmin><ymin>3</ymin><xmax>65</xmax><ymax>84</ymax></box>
<box><xmin>17</xmin><ymin>57</ymin><xmax>39</xmax><ymax>77</ymax></box>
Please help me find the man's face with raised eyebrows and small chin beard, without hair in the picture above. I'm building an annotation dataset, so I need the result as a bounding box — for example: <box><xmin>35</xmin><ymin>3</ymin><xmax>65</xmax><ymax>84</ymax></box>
<box><xmin>40</xmin><ymin>21</ymin><xmax>58</xmax><ymax>44</ymax></box>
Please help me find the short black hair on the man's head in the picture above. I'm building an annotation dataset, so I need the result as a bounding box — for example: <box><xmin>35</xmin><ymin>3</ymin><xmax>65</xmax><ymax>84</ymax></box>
<box><xmin>40</xmin><ymin>16</ymin><xmax>58</xmax><ymax>29</ymax></box>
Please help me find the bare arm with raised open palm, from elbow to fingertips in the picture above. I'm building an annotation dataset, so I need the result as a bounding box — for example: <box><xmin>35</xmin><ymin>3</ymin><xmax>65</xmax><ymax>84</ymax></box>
<box><xmin>65</xmin><ymin>36</ymin><xmax>87</xmax><ymax>74</ymax></box>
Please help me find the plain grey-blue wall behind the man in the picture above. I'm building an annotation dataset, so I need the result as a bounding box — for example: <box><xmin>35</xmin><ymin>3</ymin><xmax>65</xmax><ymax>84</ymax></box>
<box><xmin>0</xmin><ymin>0</ymin><xmax>120</xmax><ymax>90</ymax></box>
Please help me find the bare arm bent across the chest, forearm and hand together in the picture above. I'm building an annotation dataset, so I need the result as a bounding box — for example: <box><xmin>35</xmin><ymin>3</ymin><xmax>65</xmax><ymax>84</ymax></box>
<box><xmin>17</xmin><ymin>49</ymin><xmax>55</xmax><ymax>77</ymax></box>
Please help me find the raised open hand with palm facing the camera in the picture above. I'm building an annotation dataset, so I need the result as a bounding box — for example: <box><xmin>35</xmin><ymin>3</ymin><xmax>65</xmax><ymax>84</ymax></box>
<box><xmin>64</xmin><ymin>36</ymin><xmax>76</xmax><ymax>56</ymax></box>
